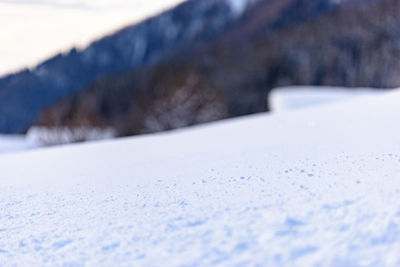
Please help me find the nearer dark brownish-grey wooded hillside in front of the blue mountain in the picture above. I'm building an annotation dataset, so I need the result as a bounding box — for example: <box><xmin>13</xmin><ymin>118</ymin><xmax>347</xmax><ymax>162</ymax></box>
<box><xmin>38</xmin><ymin>0</ymin><xmax>400</xmax><ymax>135</ymax></box>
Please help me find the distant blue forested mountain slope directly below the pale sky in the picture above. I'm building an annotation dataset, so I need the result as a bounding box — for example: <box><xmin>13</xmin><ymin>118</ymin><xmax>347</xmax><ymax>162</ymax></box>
<box><xmin>0</xmin><ymin>0</ymin><xmax>260</xmax><ymax>133</ymax></box>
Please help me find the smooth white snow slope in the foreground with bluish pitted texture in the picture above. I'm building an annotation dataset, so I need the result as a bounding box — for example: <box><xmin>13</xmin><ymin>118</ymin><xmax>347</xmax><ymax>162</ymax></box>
<box><xmin>0</xmin><ymin>91</ymin><xmax>400</xmax><ymax>266</ymax></box>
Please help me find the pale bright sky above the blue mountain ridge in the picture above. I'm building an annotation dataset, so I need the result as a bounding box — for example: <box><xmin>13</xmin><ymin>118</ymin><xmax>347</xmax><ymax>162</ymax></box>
<box><xmin>0</xmin><ymin>0</ymin><xmax>185</xmax><ymax>76</ymax></box>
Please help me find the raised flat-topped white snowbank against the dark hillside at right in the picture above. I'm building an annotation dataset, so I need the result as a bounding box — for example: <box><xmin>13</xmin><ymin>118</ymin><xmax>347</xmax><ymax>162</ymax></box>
<box><xmin>268</xmin><ymin>86</ymin><xmax>384</xmax><ymax>112</ymax></box>
